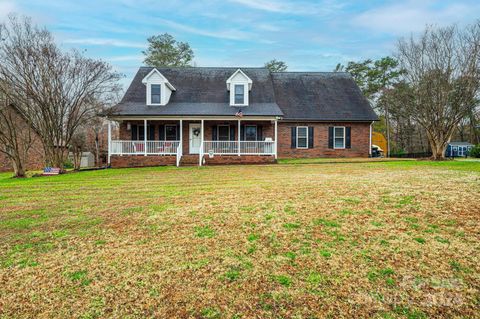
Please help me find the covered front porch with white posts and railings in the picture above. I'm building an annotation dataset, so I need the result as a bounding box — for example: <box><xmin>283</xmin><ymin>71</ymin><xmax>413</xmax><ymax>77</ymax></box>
<box><xmin>108</xmin><ymin>118</ymin><xmax>277</xmax><ymax>166</ymax></box>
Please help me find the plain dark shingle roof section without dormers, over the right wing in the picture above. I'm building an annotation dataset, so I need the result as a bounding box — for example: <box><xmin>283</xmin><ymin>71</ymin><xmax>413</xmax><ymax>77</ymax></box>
<box><xmin>272</xmin><ymin>72</ymin><xmax>378</xmax><ymax>121</ymax></box>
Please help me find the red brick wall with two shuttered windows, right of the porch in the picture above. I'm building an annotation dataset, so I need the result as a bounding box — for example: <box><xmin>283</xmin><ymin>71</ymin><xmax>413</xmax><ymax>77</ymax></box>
<box><xmin>278</xmin><ymin>122</ymin><xmax>370</xmax><ymax>158</ymax></box>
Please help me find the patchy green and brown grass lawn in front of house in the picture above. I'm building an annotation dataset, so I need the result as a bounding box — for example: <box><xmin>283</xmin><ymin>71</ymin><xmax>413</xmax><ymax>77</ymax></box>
<box><xmin>0</xmin><ymin>161</ymin><xmax>480</xmax><ymax>318</ymax></box>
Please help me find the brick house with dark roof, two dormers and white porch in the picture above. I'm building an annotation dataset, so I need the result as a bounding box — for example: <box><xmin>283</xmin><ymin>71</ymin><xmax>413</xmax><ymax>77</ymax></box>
<box><xmin>107</xmin><ymin>67</ymin><xmax>378</xmax><ymax>167</ymax></box>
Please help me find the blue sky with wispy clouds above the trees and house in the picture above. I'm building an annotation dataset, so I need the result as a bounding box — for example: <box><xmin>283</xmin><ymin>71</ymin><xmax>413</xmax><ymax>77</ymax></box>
<box><xmin>0</xmin><ymin>0</ymin><xmax>480</xmax><ymax>85</ymax></box>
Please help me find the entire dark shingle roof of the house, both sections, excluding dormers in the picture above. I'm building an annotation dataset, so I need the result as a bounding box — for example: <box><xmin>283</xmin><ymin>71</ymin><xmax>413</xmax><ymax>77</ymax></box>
<box><xmin>113</xmin><ymin>67</ymin><xmax>377</xmax><ymax>121</ymax></box>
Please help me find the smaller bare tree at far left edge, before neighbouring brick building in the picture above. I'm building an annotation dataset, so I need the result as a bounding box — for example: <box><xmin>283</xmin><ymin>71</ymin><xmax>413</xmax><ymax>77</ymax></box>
<box><xmin>0</xmin><ymin>92</ymin><xmax>35</xmax><ymax>177</ymax></box>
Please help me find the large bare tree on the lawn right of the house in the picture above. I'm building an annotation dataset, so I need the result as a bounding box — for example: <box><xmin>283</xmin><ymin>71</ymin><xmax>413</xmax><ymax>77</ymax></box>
<box><xmin>397</xmin><ymin>20</ymin><xmax>480</xmax><ymax>159</ymax></box>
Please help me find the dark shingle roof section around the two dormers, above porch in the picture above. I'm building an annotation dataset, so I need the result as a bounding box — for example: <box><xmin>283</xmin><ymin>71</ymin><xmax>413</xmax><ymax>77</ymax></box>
<box><xmin>115</xmin><ymin>67</ymin><xmax>283</xmax><ymax>116</ymax></box>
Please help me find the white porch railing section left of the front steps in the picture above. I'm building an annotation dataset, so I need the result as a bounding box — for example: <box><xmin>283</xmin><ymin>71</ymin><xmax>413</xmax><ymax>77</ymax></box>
<box><xmin>110</xmin><ymin>140</ymin><xmax>180</xmax><ymax>155</ymax></box>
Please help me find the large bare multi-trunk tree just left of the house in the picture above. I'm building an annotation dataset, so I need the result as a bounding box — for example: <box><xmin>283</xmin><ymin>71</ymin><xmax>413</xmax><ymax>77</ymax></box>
<box><xmin>0</xmin><ymin>16</ymin><xmax>121</xmax><ymax>169</ymax></box>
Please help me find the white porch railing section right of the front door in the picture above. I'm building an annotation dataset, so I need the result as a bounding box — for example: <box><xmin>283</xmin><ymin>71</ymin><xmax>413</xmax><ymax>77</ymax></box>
<box><xmin>203</xmin><ymin>141</ymin><xmax>275</xmax><ymax>155</ymax></box>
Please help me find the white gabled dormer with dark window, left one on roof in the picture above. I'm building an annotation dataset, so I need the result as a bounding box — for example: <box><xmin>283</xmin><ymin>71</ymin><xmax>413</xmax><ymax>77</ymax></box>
<box><xmin>142</xmin><ymin>68</ymin><xmax>175</xmax><ymax>105</ymax></box>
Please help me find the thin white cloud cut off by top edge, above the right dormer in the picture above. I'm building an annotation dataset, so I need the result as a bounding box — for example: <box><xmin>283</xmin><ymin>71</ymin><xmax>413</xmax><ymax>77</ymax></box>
<box><xmin>229</xmin><ymin>0</ymin><xmax>343</xmax><ymax>15</ymax></box>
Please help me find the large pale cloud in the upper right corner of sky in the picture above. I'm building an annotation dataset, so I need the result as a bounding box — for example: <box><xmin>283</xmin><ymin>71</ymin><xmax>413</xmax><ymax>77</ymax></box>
<box><xmin>352</xmin><ymin>0</ymin><xmax>480</xmax><ymax>35</ymax></box>
